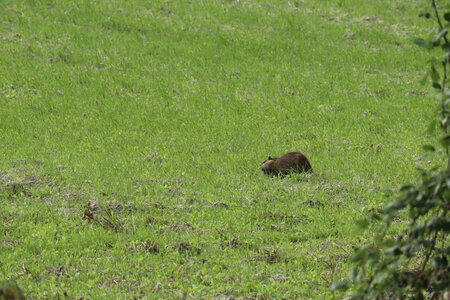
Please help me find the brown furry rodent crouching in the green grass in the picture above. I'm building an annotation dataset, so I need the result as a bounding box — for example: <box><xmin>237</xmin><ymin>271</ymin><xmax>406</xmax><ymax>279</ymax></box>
<box><xmin>259</xmin><ymin>152</ymin><xmax>312</xmax><ymax>175</ymax></box>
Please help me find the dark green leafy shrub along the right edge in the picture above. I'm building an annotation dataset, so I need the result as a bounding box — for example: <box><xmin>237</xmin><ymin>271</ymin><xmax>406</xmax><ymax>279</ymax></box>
<box><xmin>332</xmin><ymin>0</ymin><xmax>450</xmax><ymax>299</ymax></box>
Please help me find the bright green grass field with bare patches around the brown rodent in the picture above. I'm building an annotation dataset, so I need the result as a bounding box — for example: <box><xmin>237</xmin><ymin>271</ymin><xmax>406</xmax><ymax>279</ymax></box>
<box><xmin>0</xmin><ymin>0</ymin><xmax>440</xmax><ymax>299</ymax></box>
